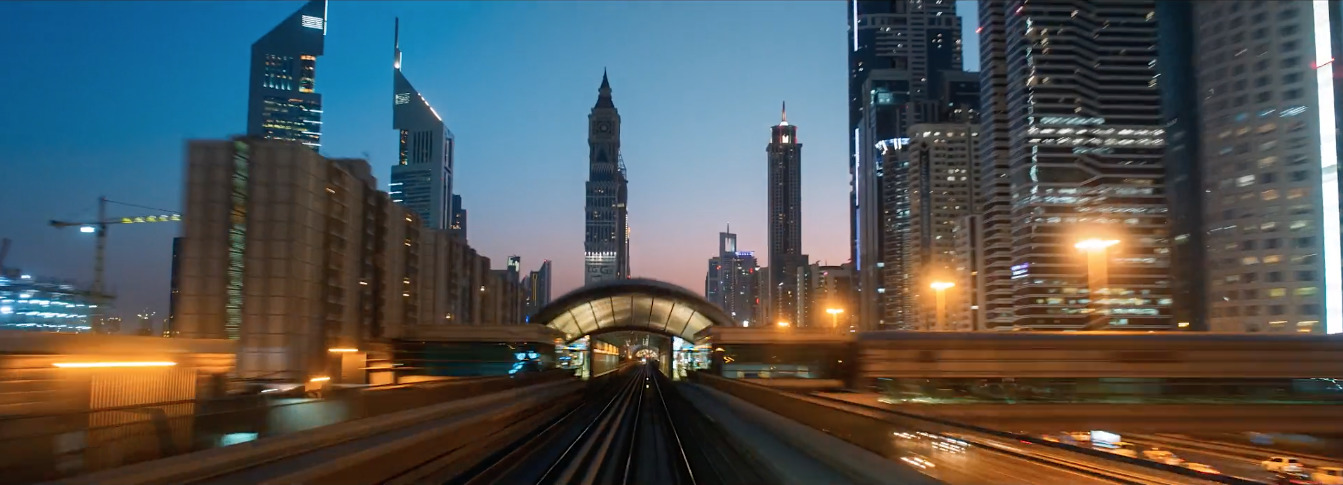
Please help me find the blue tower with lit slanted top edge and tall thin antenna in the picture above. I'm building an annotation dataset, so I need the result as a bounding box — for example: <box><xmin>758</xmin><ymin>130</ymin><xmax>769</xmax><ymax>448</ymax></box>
<box><xmin>388</xmin><ymin>19</ymin><xmax>454</xmax><ymax>230</ymax></box>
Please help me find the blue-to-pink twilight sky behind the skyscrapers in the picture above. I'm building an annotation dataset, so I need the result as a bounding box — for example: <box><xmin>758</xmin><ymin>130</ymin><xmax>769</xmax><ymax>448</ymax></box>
<box><xmin>0</xmin><ymin>0</ymin><xmax>979</xmax><ymax>317</ymax></box>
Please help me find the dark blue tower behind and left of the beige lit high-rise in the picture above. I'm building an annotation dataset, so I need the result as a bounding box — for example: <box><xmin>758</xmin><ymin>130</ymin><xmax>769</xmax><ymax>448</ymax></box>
<box><xmin>849</xmin><ymin>0</ymin><xmax>974</xmax><ymax>329</ymax></box>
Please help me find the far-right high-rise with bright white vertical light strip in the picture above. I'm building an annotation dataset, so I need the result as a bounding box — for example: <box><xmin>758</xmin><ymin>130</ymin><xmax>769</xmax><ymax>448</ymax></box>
<box><xmin>1193</xmin><ymin>1</ymin><xmax>1343</xmax><ymax>333</ymax></box>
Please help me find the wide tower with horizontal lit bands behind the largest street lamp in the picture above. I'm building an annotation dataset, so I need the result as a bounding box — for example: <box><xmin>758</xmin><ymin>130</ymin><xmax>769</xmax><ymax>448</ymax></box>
<box><xmin>980</xmin><ymin>0</ymin><xmax>1175</xmax><ymax>330</ymax></box>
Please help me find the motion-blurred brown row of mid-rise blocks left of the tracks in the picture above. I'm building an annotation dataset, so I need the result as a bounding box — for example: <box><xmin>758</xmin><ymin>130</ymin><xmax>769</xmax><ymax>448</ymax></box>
<box><xmin>173</xmin><ymin>138</ymin><xmax>521</xmax><ymax>382</ymax></box>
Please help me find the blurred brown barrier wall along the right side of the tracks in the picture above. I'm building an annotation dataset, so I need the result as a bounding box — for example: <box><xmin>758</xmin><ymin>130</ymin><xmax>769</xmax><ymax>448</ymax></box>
<box><xmin>694</xmin><ymin>373</ymin><xmax>1258</xmax><ymax>485</ymax></box>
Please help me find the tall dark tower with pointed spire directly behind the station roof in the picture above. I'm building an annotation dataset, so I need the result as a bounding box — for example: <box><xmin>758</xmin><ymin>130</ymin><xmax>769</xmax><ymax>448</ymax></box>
<box><xmin>583</xmin><ymin>71</ymin><xmax>630</xmax><ymax>285</ymax></box>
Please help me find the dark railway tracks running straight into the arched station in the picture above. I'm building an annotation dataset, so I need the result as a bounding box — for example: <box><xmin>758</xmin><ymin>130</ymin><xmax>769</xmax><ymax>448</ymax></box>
<box><xmin>447</xmin><ymin>363</ymin><xmax>771</xmax><ymax>485</ymax></box>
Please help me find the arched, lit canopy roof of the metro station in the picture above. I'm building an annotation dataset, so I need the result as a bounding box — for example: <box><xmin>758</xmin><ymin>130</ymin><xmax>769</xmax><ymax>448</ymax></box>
<box><xmin>532</xmin><ymin>279</ymin><xmax>735</xmax><ymax>341</ymax></box>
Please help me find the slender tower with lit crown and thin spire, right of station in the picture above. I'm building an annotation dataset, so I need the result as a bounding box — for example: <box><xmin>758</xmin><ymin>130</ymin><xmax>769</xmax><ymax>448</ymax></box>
<box><xmin>766</xmin><ymin>105</ymin><xmax>807</xmax><ymax>324</ymax></box>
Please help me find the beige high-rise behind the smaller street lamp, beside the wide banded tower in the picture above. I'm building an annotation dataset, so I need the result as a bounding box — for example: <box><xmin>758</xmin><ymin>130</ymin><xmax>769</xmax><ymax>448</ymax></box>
<box><xmin>888</xmin><ymin>122</ymin><xmax>979</xmax><ymax>332</ymax></box>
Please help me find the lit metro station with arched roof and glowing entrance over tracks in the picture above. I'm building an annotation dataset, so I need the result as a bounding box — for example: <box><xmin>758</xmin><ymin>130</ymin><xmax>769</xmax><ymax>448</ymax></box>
<box><xmin>530</xmin><ymin>279</ymin><xmax>736</xmax><ymax>378</ymax></box>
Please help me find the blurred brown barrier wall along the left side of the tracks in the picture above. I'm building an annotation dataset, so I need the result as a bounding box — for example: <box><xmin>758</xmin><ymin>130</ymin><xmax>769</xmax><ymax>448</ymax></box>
<box><xmin>0</xmin><ymin>371</ymin><xmax>572</xmax><ymax>484</ymax></box>
